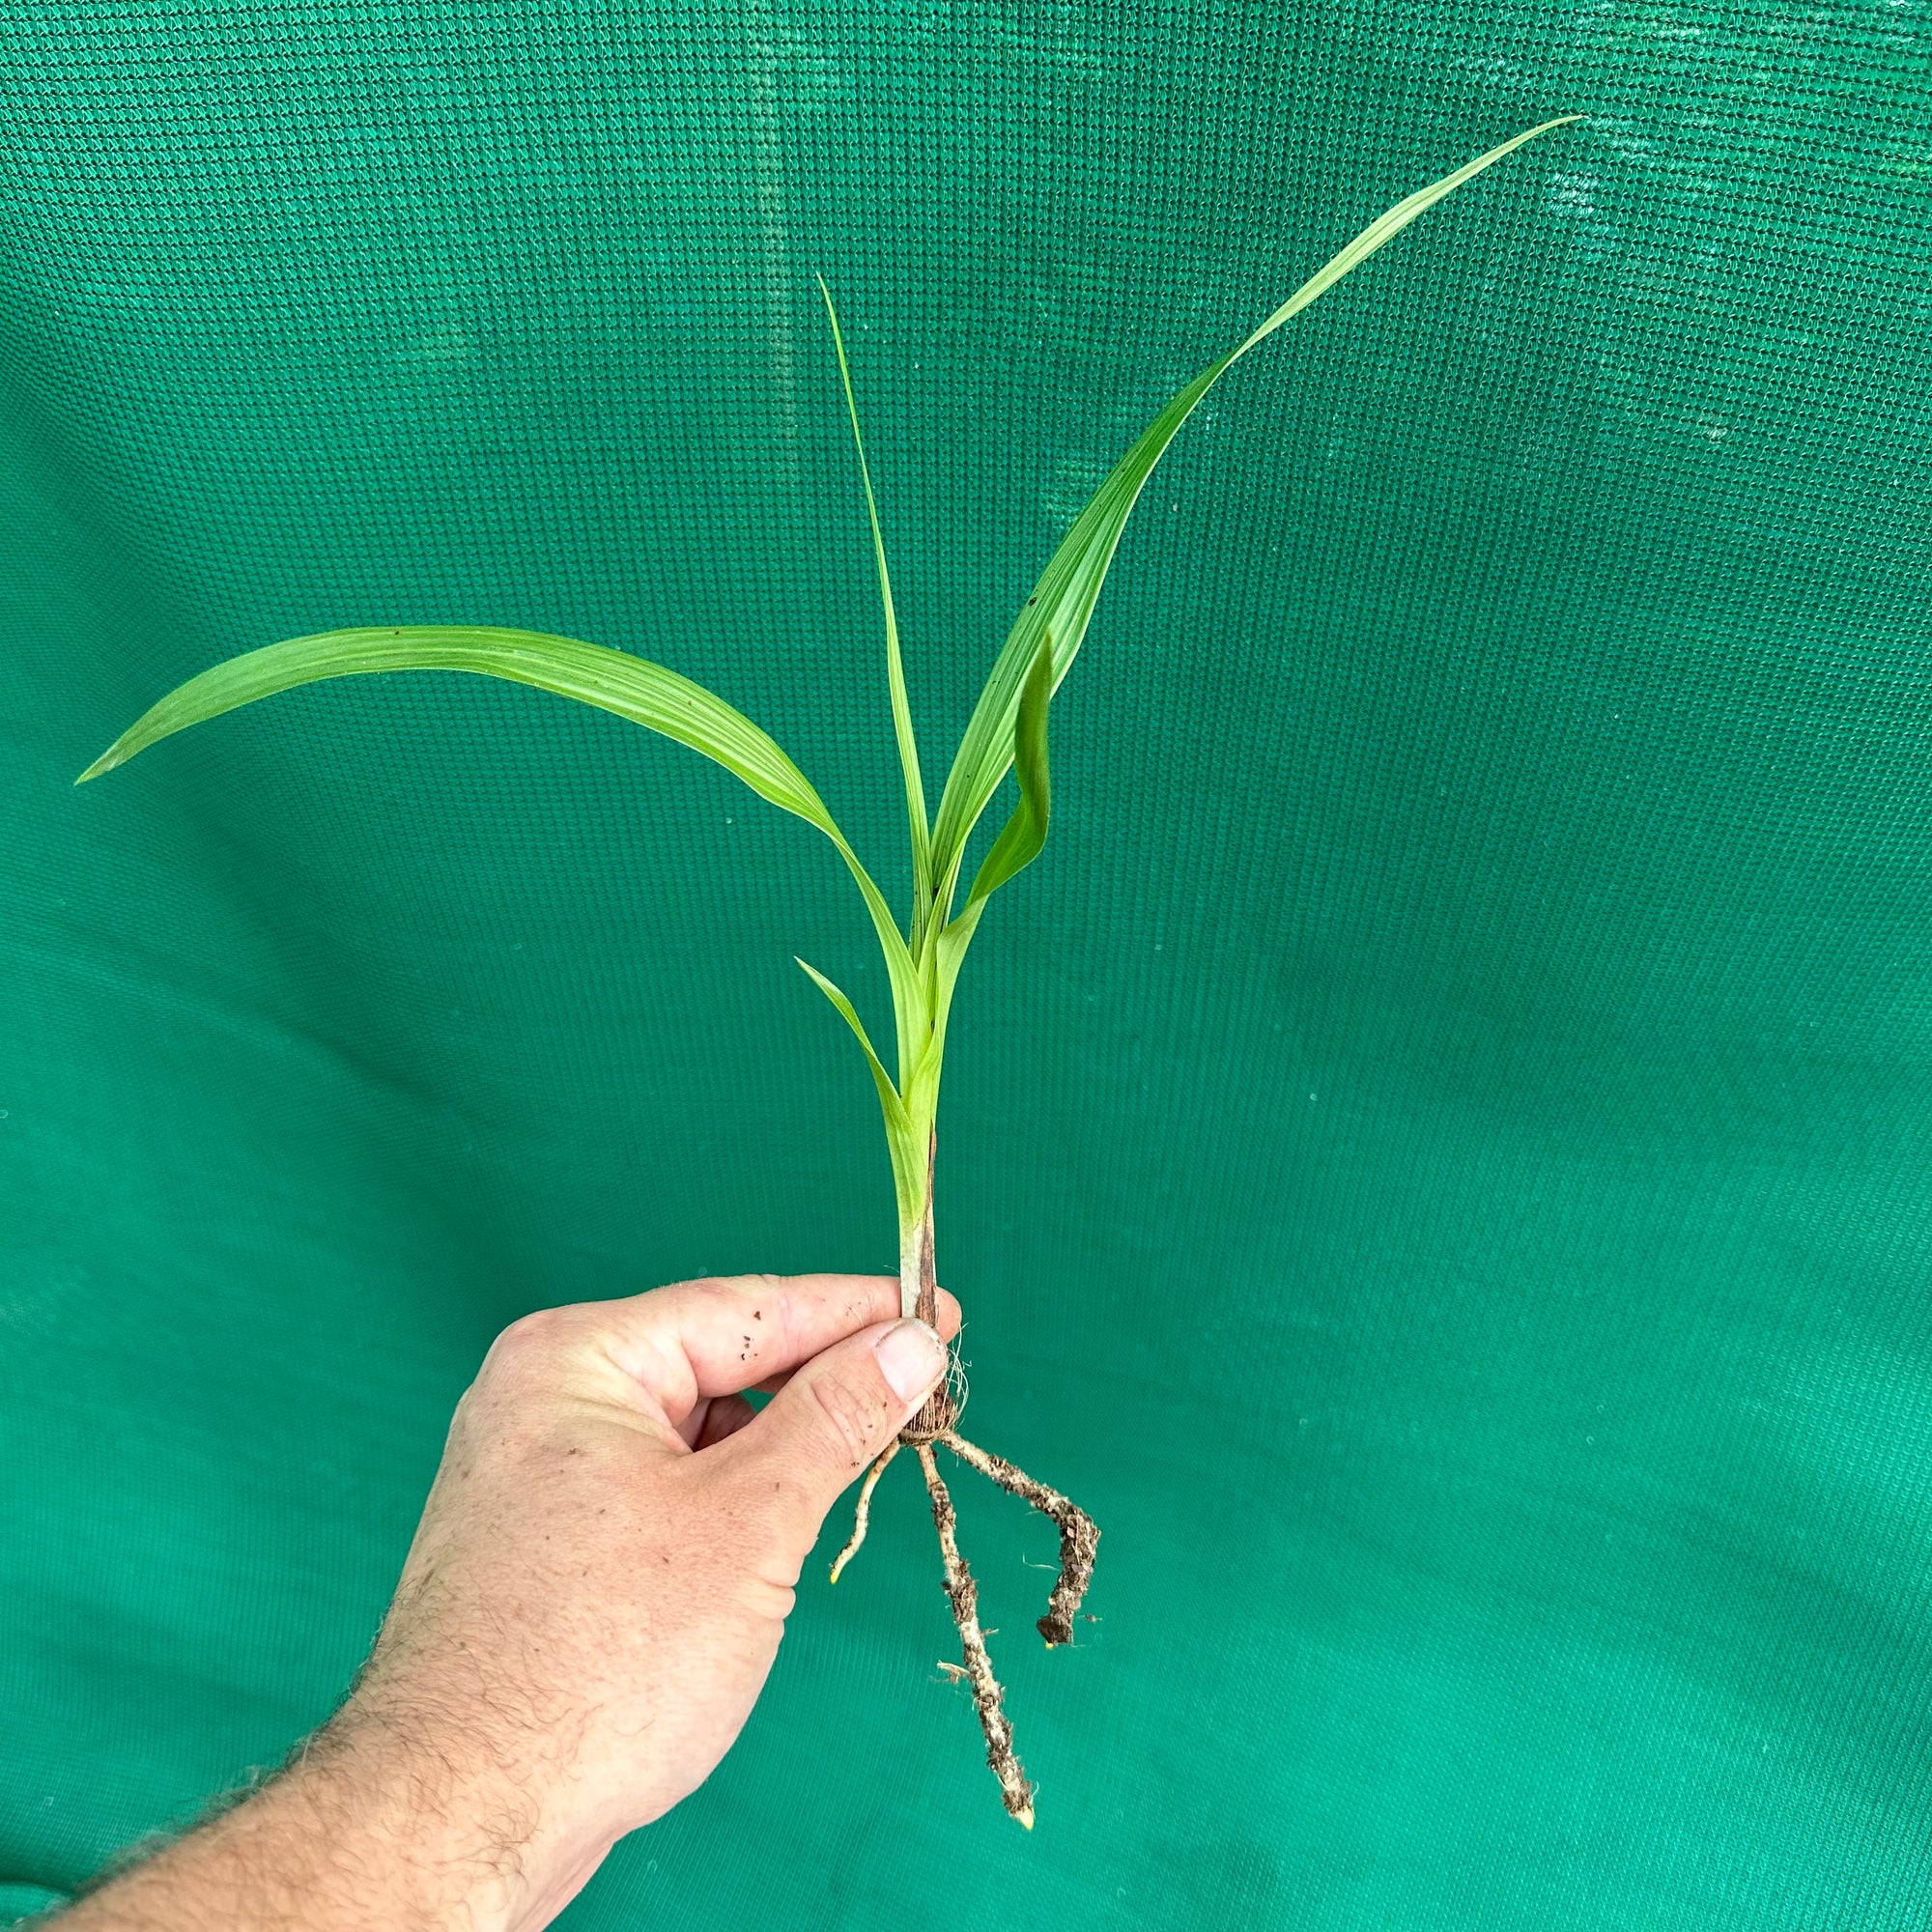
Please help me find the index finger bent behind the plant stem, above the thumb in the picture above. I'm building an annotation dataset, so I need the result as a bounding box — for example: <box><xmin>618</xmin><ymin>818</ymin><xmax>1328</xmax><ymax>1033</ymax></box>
<box><xmin>576</xmin><ymin>1275</ymin><xmax>958</xmax><ymax>1426</ymax></box>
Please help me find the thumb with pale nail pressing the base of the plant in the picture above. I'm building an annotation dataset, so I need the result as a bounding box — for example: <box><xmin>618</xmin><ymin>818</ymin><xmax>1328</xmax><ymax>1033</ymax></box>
<box><xmin>713</xmin><ymin>1320</ymin><xmax>947</xmax><ymax>1557</ymax></box>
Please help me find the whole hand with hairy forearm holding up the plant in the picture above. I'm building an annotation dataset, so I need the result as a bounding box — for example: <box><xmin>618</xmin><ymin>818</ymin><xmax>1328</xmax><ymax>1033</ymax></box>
<box><xmin>56</xmin><ymin>1275</ymin><xmax>958</xmax><ymax>1932</ymax></box>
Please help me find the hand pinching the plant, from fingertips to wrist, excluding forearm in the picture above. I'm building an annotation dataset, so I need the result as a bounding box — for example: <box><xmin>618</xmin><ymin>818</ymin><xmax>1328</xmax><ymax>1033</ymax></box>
<box><xmin>344</xmin><ymin>1275</ymin><xmax>958</xmax><ymax>1911</ymax></box>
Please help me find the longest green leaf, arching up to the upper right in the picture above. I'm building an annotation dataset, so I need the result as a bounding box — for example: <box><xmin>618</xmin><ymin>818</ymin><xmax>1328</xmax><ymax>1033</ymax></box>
<box><xmin>933</xmin><ymin>114</ymin><xmax>1582</xmax><ymax>916</ymax></box>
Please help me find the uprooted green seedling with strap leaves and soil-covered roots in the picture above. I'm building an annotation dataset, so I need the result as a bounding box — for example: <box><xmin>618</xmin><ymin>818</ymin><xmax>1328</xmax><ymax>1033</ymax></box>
<box><xmin>75</xmin><ymin>114</ymin><xmax>1580</xmax><ymax>1828</ymax></box>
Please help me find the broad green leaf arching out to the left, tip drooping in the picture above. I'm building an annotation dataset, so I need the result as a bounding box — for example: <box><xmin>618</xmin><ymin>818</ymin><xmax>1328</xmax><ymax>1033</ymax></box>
<box><xmin>75</xmin><ymin>624</ymin><xmax>920</xmax><ymax>1043</ymax></box>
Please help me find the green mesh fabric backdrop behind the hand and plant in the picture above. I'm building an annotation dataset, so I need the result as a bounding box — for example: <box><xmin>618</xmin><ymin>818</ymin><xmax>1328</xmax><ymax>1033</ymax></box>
<box><xmin>0</xmin><ymin>0</ymin><xmax>1932</xmax><ymax>1932</ymax></box>
